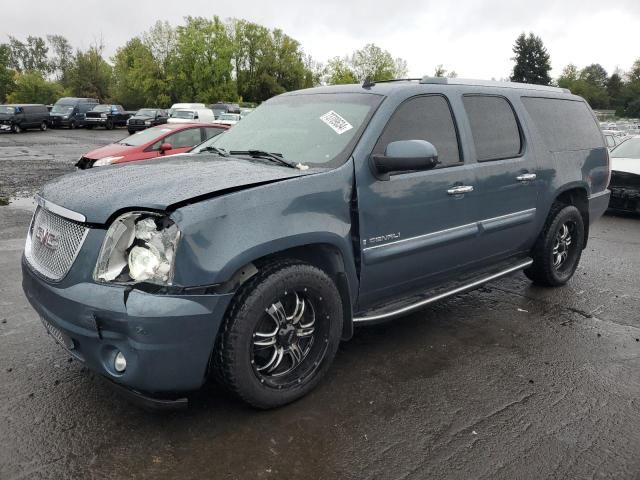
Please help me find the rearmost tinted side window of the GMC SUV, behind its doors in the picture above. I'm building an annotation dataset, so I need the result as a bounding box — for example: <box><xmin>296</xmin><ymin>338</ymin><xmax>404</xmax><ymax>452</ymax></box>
<box><xmin>522</xmin><ymin>97</ymin><xmax>602</xmax><ymax>152</ymax></box>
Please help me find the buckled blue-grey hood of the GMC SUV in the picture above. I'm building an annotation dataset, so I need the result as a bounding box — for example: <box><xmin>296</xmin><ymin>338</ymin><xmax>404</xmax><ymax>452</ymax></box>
<box><xmin>40</xmin><ymin>154</ymin><xmax>324</xmax><ymax>224</ymax></box>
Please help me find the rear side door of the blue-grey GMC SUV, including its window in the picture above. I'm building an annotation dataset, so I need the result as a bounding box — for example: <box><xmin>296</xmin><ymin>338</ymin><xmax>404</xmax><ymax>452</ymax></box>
<box><xmin>462</xmin><ymin>94</ymin><xmax>538</xmax><ymax>263</ymax></box>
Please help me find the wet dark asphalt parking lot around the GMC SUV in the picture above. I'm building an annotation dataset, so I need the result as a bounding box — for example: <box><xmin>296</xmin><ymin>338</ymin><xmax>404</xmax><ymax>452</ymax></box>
<box><xmin>0</xmin><ymin>130</ymin><xmax>640</xmax><ymax>480</ymax></box>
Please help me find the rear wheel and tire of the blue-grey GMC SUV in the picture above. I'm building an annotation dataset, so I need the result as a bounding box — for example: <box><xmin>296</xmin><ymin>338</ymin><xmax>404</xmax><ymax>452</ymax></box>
<box><xmin>524</xmin><ymin>204</ymin><xmax>585</xmax><ymax>287</ymax></box>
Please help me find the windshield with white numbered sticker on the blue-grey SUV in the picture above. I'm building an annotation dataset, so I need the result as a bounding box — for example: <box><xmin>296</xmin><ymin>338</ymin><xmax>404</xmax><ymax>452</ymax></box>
<box><xmin>212</xmin><ymin>93</ymin><xmax>383</xmax><ymax>167</ymax></box>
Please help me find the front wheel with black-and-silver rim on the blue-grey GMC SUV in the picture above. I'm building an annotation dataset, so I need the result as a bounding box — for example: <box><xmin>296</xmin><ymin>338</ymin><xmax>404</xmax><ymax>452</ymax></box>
<box><xmin>212</xmin><ymin>261</ymin><xmax>343</xmax><ymax>409</ymax></box>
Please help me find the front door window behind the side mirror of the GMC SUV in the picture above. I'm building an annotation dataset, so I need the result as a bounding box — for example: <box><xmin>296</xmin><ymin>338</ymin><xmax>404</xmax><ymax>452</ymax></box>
<box><xmin>373</xmin><ymin>95</ymin><xmax>460</xmax><ymax>166</ymax></box>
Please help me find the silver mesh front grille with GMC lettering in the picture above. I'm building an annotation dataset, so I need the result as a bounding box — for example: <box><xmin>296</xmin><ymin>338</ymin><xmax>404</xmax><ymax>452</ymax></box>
<box><xmin>24</xmin><ymin>206</ymin><xmax>89</xmax><ymax>281</ymax></box>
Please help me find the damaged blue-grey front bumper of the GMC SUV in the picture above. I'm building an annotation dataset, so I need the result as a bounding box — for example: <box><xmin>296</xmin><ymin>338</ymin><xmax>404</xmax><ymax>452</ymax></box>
<box><xmin>22</xmin><ymin>257</ymin><xmax>238</xmax><ymax>398</ymax></box>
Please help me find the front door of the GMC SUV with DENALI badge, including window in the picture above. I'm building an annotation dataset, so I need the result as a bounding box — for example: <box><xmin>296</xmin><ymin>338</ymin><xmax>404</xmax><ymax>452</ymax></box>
<box><xmin>356</xmin><ymin>95</ymin><xmax>477</xmax><ymax>308</ymax></box>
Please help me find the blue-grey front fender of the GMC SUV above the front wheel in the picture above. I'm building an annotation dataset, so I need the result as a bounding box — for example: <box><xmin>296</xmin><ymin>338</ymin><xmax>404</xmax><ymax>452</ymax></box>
<box><xmin>172</xmin><ymin>162</ymin><xmax>355</xmax><ymax>287</ymax></box>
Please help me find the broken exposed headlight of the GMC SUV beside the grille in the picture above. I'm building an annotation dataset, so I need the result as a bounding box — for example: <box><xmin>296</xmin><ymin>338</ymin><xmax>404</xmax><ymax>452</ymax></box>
<box><xmin>93</xmin><ymin>212</ymin><xmax>180</xmax><ymax>285</ymax></box>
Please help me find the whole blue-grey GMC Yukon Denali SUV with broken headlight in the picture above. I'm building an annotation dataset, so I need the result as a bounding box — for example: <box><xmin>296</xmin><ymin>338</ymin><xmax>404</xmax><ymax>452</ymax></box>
<box><xmin>22</xmin><ymin>78</ymin><xmax>610</xmax><ymax>408</ymax></box>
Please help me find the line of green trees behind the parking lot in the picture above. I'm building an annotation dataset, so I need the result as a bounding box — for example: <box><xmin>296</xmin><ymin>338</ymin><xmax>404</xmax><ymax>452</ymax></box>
<box><xmin>0</xmin><ymin>20</ymin><xmax>640</xmax><ymax>117</ymax></box>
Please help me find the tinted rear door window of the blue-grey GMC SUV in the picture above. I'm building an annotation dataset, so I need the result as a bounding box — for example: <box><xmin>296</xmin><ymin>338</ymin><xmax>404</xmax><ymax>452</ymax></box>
<box><xmin>462</xmin><ymin>95</ymin><xmax>522</xmax><ymax>162</ymax></box>
